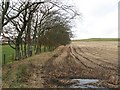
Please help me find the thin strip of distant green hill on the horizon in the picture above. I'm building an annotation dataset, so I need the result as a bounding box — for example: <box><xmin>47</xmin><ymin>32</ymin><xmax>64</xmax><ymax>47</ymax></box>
<box><xmin>72</xmin><ymin>38</ymin><xmax>120</xmax><ymax>41</ymax></box>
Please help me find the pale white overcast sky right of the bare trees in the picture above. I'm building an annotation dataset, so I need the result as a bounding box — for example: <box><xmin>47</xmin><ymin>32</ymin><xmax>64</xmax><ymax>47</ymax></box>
<box><xmin>67</xmin><ymin>0</ymin><xmax>120</xmax><ymax>39</ymax></box>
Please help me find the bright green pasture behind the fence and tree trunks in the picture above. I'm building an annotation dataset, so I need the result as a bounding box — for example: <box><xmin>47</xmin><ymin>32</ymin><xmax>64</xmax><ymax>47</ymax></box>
<box><xmin>2</xmin><ymin>46</ymin><xmax>55</xmax><ymax>65</ymax></box>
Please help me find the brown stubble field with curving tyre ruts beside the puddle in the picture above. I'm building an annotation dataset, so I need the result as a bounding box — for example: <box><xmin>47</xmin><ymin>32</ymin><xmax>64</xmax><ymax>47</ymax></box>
<box><xmin>43</xmin><ymin>42</ymin><xmax>118</xmax><ymax>88</ymax></box>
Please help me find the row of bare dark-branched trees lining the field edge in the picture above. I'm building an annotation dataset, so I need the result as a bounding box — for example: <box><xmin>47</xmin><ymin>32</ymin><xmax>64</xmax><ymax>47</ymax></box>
<box><xmin>0</xmin><ymin>0</ymin><xmax>79</xmax><ymax>60</ymax></box>
